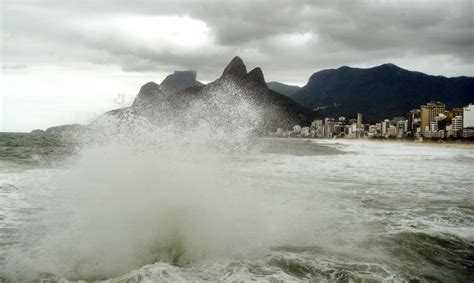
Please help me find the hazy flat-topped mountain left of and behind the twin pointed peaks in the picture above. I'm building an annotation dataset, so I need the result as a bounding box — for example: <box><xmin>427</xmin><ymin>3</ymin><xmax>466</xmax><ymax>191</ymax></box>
<box><xmin>133</xmin><ymin>71</ymin><xmax>202</xmax><ymax>105</ymax></box>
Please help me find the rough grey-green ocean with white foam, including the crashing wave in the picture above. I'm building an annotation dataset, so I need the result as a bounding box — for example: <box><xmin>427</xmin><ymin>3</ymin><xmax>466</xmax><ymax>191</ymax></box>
<box><xmin>0</xmin><ymin>131</ymin><xmax>474</xmax><ymax>282</ymax></box>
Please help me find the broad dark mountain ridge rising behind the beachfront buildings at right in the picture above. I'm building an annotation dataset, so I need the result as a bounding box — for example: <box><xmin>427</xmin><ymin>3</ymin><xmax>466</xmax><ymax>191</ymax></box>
<box><xmin>290</xmin><ymin>64</ymin><xmax>474</xmax><ymax>121</ymax></box>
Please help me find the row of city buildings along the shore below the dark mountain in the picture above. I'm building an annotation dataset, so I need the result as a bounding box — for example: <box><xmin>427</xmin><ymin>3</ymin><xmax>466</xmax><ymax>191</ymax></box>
<box><xmin>272</xmin><ymin>102</ymin><xmax>474</xmax><ymax>140</ymax></box>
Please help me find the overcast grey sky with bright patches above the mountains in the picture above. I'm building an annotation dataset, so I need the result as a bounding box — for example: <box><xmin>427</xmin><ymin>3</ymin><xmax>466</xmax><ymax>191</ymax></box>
<box><xmin>0</xmin><ymin>0</ymin><xmax>474</xmax><ymax>131</ymax></box>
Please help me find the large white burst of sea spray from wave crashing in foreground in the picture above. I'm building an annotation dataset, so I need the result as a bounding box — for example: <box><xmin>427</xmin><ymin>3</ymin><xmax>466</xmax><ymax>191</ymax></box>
<box><xmin>5</xmin><ymin>84</ymin><xmax>316</xmax><ymax>280</ymax></box>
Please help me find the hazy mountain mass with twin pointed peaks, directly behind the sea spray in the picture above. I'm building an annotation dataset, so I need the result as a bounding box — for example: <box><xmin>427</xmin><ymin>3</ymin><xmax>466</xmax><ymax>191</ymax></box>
<box><xmin>107</xmin><ymin>56</ymin><xmax>314</xmax><ymax>133</ymax></box>
